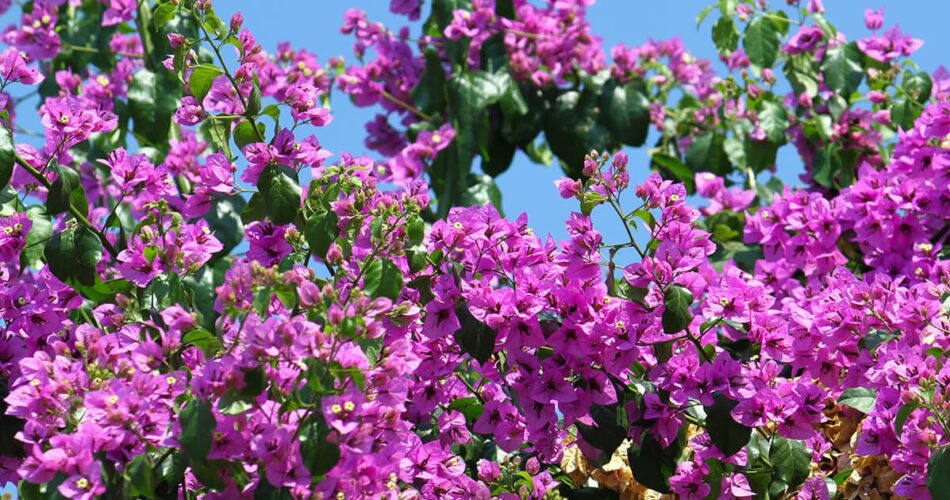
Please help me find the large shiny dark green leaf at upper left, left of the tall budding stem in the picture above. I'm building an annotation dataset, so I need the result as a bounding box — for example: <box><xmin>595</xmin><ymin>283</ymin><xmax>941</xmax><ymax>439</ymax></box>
<box><xmin>128</xmin><ymin>69</ymin><xmax>181</xmax><ymax>145</ymax></box>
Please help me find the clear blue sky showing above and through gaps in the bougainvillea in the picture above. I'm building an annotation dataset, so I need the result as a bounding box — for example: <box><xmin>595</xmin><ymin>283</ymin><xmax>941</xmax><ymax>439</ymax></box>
<box><xmin>0</xmin><ymin>0</ymin><xmax>950</xmax><ymax>244</ymax></box>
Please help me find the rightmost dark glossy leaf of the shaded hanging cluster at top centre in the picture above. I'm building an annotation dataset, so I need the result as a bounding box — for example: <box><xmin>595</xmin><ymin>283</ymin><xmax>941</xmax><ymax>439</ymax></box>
<box><xmin>599</xmin><ymin>80</ymin><xmax>650</xmax><ymax>146</ymax></box>
